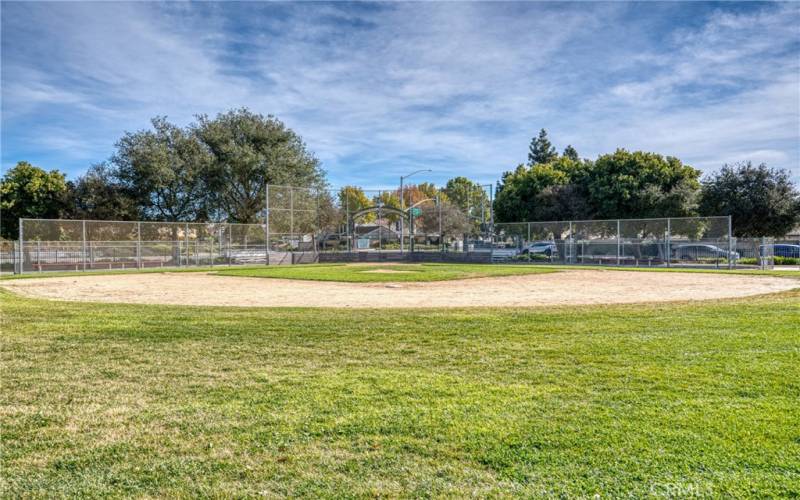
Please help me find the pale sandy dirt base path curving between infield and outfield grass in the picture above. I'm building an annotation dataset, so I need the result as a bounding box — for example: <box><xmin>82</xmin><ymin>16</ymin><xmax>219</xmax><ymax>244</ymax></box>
<box><xmin>2</xmin><ymin>269</ymin><xmax>800</xmax><ymax>308</ymax></box>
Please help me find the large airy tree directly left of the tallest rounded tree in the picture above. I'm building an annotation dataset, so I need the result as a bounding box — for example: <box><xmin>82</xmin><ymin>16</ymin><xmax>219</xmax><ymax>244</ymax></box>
<box><xmin>111</xmin><ymin>117</ymin><xmax>214</xmax><ymax>221</ymax></box>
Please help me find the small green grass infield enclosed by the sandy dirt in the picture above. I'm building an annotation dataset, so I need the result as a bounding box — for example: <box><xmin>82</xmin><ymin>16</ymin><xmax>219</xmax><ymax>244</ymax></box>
<box><xmin>217</xmin><ymin>263</ymin><xmax>556</xmax><ymax>283</ymax></box>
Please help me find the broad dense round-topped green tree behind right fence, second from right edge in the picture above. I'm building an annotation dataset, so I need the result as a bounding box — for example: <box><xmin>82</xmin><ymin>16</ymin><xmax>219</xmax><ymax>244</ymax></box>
<box><xmin>586</xmin><ymin>149</ymin><xmax>700</xmax><ymax>219</ymax></box>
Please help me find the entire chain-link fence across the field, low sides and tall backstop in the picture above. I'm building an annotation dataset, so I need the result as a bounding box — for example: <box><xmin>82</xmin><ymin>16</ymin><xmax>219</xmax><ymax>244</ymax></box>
<box><xmin>10</xmin><ymin>183</ymin><xmax>800</xmax><ymax>272</ymax></box>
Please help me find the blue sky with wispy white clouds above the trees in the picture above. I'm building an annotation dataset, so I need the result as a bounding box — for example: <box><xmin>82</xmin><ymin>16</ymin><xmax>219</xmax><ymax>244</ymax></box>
<box><xmin>0</xmin><ymin>2</ymin><xmax>800</xmax><ymax>186</ymax></box>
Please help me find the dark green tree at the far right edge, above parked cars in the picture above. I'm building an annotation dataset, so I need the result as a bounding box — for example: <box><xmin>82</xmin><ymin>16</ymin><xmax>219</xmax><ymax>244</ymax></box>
<box><xmin>700</xmin><ymin>162</ymin><xmax>800</xmax><ymax>237</ymax></box>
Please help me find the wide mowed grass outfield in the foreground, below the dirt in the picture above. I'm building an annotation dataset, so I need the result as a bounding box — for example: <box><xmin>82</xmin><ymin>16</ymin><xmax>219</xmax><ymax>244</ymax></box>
<box><xmin>0</xmin><ymin>292</ymin><xmax>800</xmax><ymax>497</ymax></box>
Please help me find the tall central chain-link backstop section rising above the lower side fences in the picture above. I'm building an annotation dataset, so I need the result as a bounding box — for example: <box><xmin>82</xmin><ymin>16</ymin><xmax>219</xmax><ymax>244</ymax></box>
<box><xmin>265</xmin><ymin>183</ymin><xmax>492</xmax><ymax>252</ymax></box>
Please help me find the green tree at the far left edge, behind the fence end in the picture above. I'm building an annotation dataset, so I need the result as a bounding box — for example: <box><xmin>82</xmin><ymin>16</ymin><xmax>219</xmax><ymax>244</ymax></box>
<box><xmin>0</xmin><ymin>161</ymin><xmax>68</xmax><ymax>239</ymax></box>
